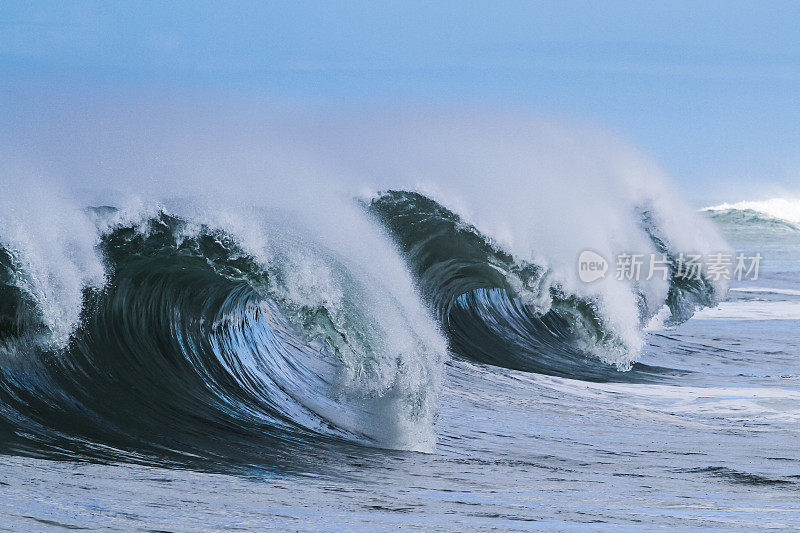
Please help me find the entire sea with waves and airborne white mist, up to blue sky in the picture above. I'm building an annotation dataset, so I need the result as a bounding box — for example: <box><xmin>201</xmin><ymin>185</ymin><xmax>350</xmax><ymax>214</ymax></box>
<box><xmin>0</xmin><ymin>102</ymin><xmax>800</xmax><ymax>531</ymax></box>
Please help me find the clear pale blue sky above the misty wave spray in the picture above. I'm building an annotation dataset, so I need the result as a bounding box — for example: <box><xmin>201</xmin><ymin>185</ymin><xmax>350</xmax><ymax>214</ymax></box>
<box><xmin>0</xmin><ymin>0</ymin><xmax>800</xmax><ymax>201</ymax></box>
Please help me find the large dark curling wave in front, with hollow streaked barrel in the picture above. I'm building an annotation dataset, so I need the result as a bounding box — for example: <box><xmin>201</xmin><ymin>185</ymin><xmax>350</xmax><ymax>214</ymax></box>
<box><xmin>0</xmin><ymin>202</ymin><xmax>444</xmax><ymax>456</ymax></box>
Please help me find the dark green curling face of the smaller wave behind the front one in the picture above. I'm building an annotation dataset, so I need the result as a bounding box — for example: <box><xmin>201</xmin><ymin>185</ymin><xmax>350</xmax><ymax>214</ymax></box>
<box><xmin>368</xmin><ymin>191</ymin><xmax>719</xmax><ymax>381</ymax></box>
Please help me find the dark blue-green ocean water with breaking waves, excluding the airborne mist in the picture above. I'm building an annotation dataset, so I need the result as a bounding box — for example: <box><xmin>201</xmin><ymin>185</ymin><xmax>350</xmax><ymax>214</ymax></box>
<box><xmin>0</xmin><ymin>155</ymin><xmax>800</xmax><ymax>531</ymax></box>
